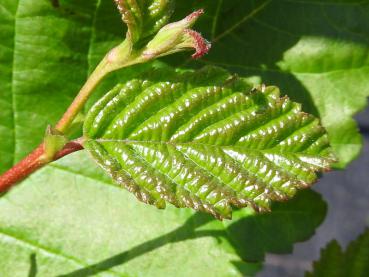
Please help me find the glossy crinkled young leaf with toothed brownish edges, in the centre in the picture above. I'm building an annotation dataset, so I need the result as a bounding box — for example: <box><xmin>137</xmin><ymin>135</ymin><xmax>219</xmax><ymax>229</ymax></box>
<box><xmin>84</xmin><ymin>68</ymin><xmax>333</xmax><ymax>219</ymax></box>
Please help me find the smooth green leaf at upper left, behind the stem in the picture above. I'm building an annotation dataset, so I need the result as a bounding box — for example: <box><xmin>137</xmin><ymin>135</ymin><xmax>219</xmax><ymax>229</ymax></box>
<box><xmin>0</xmin><ymin>0</ymin><xmax>102</xmax><ymax>172</ymax></box>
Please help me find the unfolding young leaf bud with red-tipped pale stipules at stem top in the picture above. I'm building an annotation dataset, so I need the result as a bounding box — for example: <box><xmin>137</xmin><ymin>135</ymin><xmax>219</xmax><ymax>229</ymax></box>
<box><xmin>102</xmin><ymin>0</ymin><xmax>211</xmax><ymax>72</ymax></box>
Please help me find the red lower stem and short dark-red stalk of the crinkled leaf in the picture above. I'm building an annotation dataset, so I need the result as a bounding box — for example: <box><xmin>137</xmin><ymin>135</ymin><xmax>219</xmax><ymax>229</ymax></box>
<box><xmin>0</xmin><ymin>141</ymin><xmax>83</xmax><ymax>193</ymax></box>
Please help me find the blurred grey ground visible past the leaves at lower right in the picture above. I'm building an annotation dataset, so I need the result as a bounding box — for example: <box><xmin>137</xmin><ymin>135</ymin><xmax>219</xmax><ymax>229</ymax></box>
<box><xmin>257</xmin><ymin>102</ymin><xmax>369</xmax><ymax>277</ymax></box>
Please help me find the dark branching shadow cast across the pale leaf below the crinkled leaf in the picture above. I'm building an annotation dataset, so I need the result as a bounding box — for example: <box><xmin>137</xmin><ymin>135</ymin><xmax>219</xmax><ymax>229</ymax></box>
<box><xmin>61</xmin><ymin>190</ymin><xmax>327</xmax><ymax>277</ymax></box>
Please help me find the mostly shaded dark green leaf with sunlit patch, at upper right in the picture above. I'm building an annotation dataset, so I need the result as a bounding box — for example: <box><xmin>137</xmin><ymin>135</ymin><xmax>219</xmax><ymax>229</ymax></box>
<box><xmin>170</xmin><ymin>0</ymin><xmax>369</xmax><ymax>168</ymax></box>
